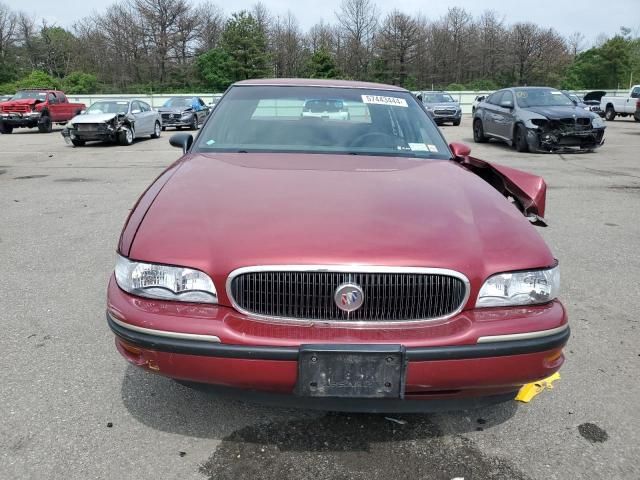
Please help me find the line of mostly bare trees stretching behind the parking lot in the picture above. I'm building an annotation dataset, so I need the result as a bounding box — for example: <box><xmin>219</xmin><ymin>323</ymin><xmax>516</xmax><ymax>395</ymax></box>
<box><xmin>0</xmin><ymin>0</ymin><xmax>640</xmax><ymax>93</ymax></box>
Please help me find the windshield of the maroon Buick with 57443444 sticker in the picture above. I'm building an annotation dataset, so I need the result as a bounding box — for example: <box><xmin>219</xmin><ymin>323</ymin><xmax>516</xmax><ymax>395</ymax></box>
<box><xmin>194</xmin><ymin>85</ymin><xmax>451</xmax><ymax>159</ymax></box>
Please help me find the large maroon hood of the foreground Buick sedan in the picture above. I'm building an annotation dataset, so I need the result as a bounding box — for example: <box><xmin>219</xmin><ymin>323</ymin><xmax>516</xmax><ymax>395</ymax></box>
<box><xmin>124</xmin><ymin>153</ymin><xmax>554</xmax><ymax>298</ymax></box>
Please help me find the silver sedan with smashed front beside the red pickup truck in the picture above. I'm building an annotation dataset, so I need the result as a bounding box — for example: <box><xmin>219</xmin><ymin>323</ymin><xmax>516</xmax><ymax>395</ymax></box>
<box><xmin>62</xmin><ymin>100</ymin><xmax>162</xmax><ymax>147</ymax></box>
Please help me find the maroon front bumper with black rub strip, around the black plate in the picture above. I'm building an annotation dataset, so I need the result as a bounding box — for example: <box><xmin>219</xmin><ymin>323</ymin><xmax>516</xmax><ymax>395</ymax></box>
<box><xmin>107</xmin><ymin>279</ymin><xmax>569</xmax><ymax>411</ymax></box>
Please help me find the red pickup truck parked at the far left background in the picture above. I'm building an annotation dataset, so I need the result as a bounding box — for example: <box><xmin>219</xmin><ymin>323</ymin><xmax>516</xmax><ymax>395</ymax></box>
<box><xmin>0</xmin><ymin>89</ymin><xmax>86</xmax><ymax>134</ymax></box>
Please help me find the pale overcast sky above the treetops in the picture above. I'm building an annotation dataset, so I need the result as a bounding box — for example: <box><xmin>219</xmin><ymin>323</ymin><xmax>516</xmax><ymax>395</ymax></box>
<box><xmin>13</xmin><ymin>0</ymin><xmax>640</xmax><ymax>47</ymax></box>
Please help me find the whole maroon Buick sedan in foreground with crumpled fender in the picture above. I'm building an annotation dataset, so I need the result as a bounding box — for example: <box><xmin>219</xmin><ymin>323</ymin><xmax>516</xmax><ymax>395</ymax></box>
<box><xmin>107</xmin><ymin>79</ymin><xmax>569</xmax><ymax>411</ymax></box>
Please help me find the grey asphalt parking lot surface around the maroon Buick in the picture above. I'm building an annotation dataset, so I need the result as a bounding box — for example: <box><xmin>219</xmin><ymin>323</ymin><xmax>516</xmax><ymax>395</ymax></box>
<box><xmin>0</xmin><ymin>118</ymin><xmax>640</xmax><ymax>480</ymax></box>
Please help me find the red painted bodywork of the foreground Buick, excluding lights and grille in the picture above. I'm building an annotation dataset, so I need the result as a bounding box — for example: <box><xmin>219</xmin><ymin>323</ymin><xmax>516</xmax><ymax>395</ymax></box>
<box><xmin>107</xmin><ymin>80</ymin><xmax>568</xmax><ymax>410</ymax></box>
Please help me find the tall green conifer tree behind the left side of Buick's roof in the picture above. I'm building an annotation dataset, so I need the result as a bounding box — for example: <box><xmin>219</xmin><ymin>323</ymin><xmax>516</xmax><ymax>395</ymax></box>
<box><xmin>220</xmin><ymin>10</ymin><xmax>270</xmax><ymax>82</ymax></box>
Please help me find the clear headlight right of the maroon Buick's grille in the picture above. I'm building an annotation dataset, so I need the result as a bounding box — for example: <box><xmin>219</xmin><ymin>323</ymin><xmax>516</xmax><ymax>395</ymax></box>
<box><xmin>476</xmin><ymin>266</ymin><xmax>560</xmax><ymax>307</ymax></box>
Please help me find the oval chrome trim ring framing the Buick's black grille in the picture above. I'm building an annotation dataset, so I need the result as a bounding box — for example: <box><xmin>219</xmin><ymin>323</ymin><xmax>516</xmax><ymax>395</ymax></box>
<box><xmin>226</xmin><ymin>264</ymin><xmax>471</xmax><ymax>327</ymax></box>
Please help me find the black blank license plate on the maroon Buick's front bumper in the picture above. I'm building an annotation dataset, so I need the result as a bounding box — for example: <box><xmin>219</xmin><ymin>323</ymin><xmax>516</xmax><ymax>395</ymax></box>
<box><xmin>296</xmin><ymin>345</ymin><xmax>406</xmax><ymax>398</ymax></box>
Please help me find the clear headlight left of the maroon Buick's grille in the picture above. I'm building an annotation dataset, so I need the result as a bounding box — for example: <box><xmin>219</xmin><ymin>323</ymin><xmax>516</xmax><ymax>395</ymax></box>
<box><xmin>116</xmin><ymin>255</ymin><xmax>218</xmax><ymax>303</ymax></box>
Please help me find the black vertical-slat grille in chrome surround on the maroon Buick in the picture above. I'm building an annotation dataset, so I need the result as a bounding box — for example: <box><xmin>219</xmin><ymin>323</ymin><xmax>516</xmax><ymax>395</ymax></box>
<box><xmin>227</xmin><ymin>267</ymin><xmax>468</xmax><ymax>322</ymax></box>
